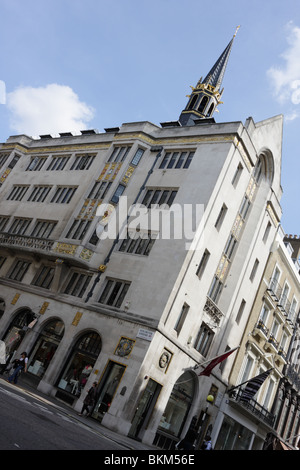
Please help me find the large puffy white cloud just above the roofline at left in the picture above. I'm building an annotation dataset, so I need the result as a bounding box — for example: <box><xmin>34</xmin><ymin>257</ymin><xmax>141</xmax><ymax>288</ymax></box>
<box><xmin>7</xmin><ymin>83</ymin><xmax>94</xmax><ymax>136</ymax></box>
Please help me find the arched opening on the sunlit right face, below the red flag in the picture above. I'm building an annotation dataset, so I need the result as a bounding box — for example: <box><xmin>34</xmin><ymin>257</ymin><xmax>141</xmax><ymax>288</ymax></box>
<box><xmin>153</xmin><ymin>371</ymin><xmax>196</xmax><ymax>448</ymax></box>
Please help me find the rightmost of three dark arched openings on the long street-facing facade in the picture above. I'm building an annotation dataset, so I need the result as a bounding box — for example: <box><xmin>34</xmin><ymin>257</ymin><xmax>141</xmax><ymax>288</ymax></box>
<box><xmin>56</xmin><ymin>331</ymin><xmax>102</xmax><ymax>403</ymax></box>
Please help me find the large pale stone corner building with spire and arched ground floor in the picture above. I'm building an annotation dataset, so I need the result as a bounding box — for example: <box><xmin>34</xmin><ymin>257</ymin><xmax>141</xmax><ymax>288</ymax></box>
<box><xmin>0</xmin><ymin>33</ymin><xmax>282</xmax><ymax>448</ymax></box>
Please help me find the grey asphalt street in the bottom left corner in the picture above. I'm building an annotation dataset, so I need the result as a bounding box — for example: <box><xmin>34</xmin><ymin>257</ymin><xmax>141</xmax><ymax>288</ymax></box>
<box><xmin>0</xmin><ymin>380</ymin><xmax>125</xmax><ymax>451</ymax></box>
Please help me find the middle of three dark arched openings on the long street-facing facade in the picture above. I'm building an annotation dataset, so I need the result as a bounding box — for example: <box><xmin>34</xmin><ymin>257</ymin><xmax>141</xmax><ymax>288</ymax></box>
<box><xmin>28</xmin><ymin>319</ymin><xmax>65</xmax><ymax>378</ymax></box>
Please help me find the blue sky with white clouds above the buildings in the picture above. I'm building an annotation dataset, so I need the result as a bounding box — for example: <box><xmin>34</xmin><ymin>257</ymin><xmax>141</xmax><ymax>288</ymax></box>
<box><xmin>0</xmin><ymin>0</ymin><xmax>300</xmax><ymax>236</ymax></box>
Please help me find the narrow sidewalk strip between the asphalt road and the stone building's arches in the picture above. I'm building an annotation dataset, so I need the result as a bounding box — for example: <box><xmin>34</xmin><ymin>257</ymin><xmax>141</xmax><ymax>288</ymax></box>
<box><xmin>0</xmin><ymin>375</ymin><xmax>159</xmax><ymax>451</ymax></box>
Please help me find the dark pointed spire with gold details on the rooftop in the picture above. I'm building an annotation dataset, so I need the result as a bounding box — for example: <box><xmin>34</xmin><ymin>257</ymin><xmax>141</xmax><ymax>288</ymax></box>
<box><xmin>179</xmin><ymin>26</ymin><xmax>239</xmax><ymax>126</ymax></box>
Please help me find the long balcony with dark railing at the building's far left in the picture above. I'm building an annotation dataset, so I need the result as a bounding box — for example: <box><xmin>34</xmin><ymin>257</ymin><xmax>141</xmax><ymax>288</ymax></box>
<box><xmin>0</xmin><ymin>232</ymin><xmax>55</xmax><ymax>251</ymax></box>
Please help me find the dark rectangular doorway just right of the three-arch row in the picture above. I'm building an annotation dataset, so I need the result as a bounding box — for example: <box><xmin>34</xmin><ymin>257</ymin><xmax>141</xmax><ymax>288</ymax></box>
<box><xmin>92</xmin><ymin>361</ymin><xmax>126</xmax><ymax>421</ymax></box>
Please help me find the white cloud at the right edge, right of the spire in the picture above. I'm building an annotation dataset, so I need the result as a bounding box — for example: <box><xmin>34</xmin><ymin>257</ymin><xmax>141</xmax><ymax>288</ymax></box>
<box><xmin>267</xmin><ymin>22</ymin><xmax>300</xmax><ymax>105</ymax></box>
